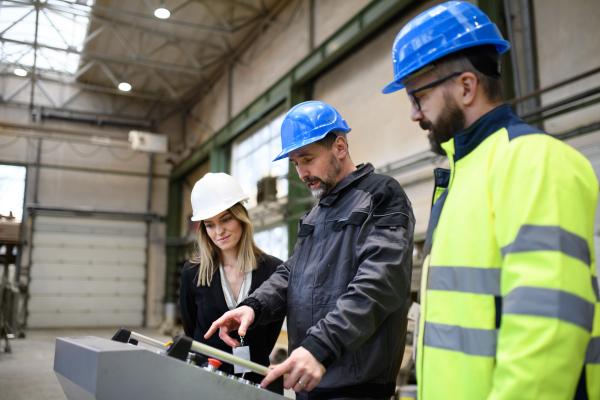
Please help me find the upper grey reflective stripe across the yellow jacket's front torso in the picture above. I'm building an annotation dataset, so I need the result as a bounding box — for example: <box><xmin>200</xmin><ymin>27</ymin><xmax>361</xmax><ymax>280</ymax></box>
<box><xmin>427</xmin><ymin>267</ymin><xmax>502</xmax><ymax>296</ymax></box>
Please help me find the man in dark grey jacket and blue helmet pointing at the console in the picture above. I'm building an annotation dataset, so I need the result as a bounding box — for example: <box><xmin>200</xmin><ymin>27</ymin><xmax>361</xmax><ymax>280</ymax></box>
<box><xmin>207</xmin><ymin>101</ymin><xmax>415</xmax><ymax>400</ymax></box>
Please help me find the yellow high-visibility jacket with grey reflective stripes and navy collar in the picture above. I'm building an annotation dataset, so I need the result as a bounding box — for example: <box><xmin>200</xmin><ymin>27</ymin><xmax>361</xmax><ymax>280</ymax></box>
<box><xmin>416</xmin><ymin>105</ymin><xmax>600</xmax><ymax>400</ymax></box>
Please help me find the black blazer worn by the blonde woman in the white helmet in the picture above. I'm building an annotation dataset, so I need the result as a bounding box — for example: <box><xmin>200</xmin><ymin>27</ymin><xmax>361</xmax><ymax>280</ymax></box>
<box><xmin>179</xmin><ymin>254</ymin><xmax>283</xmax><ymax>382</ymax></box>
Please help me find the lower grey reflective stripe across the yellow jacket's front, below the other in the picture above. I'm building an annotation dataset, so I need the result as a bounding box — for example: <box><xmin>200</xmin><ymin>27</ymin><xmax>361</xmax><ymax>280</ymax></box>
<box><xmin>423</xmin><ymin>321</ymin><xmax>498</xmax><ymax>357</ymax></box>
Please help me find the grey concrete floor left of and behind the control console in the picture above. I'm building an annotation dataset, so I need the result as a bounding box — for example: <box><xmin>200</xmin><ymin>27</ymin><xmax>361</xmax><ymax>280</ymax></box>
<box><xmin>0</xmin><ymin>328</ymin><xmax>171</xmax><ymax>400</ymax></box>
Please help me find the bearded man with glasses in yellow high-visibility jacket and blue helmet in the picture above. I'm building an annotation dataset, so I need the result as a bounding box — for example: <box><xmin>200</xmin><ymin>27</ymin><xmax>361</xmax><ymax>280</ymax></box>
<box><xmin>383</xmin><ymin>2</ymin><xmax>600</xmax><ymax>400</ymax></box>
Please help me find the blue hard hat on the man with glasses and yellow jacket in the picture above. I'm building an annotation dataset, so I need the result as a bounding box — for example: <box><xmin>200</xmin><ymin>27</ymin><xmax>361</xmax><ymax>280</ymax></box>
<box><xmin>382</xmin><ymin>1</ymin><xmax>510</xmax><ymax>93</ymax></box>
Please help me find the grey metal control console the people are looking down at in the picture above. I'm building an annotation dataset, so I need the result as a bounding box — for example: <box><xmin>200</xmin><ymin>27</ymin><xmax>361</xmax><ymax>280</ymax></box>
<box><xmin>54</xmin><ymin>329</ymin><xmax>283</xmax><ymax>400</ymax></box>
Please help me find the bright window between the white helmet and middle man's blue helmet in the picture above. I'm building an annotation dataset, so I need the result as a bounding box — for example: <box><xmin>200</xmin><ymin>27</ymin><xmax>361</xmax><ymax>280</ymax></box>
<box><xmin>231</xmin><ymin>115</ymin><xmax>289</xmax><ymax>208</ymax></box>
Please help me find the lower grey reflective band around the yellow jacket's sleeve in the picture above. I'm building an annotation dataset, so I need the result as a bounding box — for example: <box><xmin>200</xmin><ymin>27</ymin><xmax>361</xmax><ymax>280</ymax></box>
<box><xmin>502</xmin><ymin>286</ymin><xmax>594</xmax><ymax>332</ymax></box>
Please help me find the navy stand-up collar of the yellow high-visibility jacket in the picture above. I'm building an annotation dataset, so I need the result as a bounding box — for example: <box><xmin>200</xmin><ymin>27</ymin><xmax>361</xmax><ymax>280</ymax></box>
<box><xmin>442</xmin><ymin>104</ymin><xmax>519</xmax><ymax>163</ymax></box>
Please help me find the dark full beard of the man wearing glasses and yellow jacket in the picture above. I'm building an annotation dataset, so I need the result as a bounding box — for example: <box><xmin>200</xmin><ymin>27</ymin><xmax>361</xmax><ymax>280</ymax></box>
<box><xmin>419</xmin><ymin>93</ymin><xmax>465</xmax><ymax>156</ymax></box>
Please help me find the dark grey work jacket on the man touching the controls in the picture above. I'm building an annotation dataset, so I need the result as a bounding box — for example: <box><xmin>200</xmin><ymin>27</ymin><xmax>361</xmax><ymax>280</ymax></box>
<box><xmin>242</xmin><ymin>164</ymin><xmax>415</xmax><ymax>398</ymax></box>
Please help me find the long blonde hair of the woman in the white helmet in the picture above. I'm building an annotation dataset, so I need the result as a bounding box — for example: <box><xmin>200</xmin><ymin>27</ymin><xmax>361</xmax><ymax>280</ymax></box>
<box><xmin>190</xmin><ymin>203</ymin><xmax>264</xmax><ymax>286</ymax></box>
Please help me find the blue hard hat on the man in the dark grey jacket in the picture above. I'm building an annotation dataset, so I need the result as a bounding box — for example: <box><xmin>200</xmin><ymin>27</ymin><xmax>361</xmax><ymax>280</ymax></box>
<box><xmin>273</xmin><ymin>101</ymin><xmax>350</xmax><ymax>161</ymax></box>
